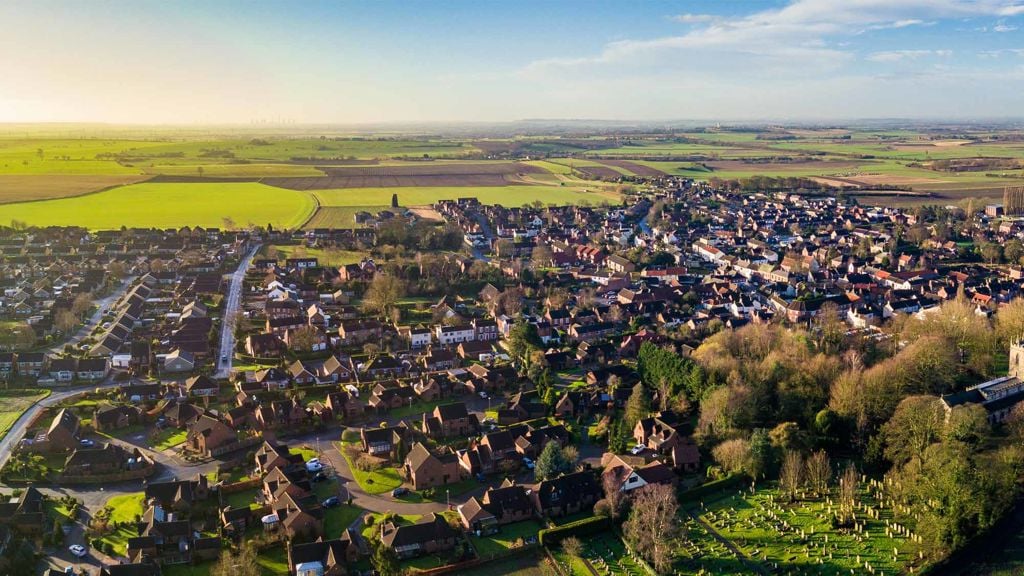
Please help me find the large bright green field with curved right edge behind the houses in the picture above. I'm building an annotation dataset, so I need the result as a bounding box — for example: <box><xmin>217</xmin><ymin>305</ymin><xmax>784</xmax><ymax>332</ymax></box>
<box><xmin>3</xmin><ymin>182</ymin><xmax>315</xmax><ymax>230</ymax></box>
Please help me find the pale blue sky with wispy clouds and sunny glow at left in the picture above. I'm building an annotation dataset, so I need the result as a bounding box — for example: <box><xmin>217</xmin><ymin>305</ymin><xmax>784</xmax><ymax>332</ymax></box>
<box><xmin>0</xmin><ymin>0</ymin><xmax>1024</xmax><ymax>124</ymax></box>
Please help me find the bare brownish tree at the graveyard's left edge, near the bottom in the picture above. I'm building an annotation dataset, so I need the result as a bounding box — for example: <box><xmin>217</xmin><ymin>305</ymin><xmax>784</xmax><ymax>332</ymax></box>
<box><xmin>623</xmin><ymin>484</ymin><xmax>679</xmax><ymax>574</ymax></box>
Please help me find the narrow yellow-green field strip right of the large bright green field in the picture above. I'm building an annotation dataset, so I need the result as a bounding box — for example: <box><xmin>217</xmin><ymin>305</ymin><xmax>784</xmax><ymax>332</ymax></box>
<box><xmin>315</xmin><ymin>186</ymin><xmax>618</xmax><ymax>206</ymax></box>
